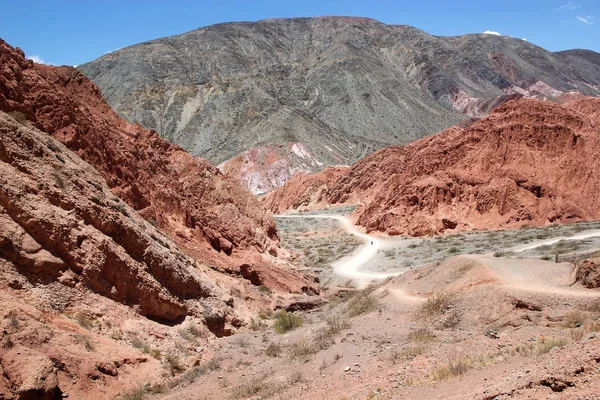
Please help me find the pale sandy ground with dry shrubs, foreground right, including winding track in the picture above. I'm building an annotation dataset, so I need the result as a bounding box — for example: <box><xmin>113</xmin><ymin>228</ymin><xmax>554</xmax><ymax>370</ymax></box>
<box><xmin>156</xmin><ymin>212</ymin><xmax>600</xmax><ymax>400</ymax></box>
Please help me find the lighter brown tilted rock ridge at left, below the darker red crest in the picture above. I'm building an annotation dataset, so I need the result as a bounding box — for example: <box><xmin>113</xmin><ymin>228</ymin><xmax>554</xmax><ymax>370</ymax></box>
<box><xmin>0</xmin><ymin>113</ymin><xmax>231</xmax><ymax>321</ymax></box>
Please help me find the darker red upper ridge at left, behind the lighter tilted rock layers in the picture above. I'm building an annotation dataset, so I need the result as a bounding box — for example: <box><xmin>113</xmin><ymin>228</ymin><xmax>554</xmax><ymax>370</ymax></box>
<box><xmin>0</xmin><ymin>40</ymin><xmax>314</xmax><ymax>291</ymax></box>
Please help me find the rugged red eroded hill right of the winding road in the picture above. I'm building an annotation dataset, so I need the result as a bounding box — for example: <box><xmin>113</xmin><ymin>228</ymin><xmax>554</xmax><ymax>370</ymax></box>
<box><xmin>264</xmin><ymin>96</ymin><xmax>600</xmax><ymax>235</ymax></box>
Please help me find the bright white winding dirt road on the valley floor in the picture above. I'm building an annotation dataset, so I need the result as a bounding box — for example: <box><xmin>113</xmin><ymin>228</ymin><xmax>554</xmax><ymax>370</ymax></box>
<box><xmin>275</xmin><ymin>215</ymin><xmax>404</xmax><ymax>287</ymax></box>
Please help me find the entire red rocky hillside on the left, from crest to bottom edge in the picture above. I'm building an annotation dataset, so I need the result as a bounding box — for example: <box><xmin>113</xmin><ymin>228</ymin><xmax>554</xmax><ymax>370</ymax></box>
<box><xmin>0</xmin><ymin>40</ymin><xmax>317</xmax><ymax>400</ymax></box>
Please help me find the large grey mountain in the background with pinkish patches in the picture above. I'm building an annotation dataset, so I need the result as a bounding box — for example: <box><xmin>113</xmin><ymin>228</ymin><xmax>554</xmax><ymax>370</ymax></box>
<box><xmin>79</xmin><ymin>17</ymin><xmax>600</xmax><ymax>193</ymax></box>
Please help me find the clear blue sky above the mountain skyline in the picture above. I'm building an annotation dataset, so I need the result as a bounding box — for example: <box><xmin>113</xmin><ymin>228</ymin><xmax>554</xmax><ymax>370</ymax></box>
<box><xmin>0</xmin><ymin>0</ymin><xmax>600</xmax><ymax>65</ymax></box>
